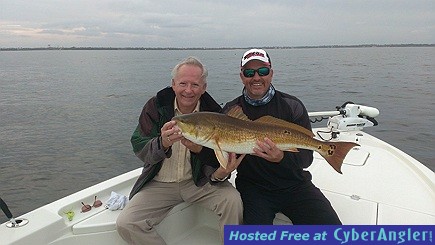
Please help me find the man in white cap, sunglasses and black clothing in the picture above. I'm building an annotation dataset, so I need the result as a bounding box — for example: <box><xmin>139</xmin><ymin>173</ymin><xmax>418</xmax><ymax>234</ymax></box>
<box><xmin>223</xmin><ymin>49</ymin><xmax>341</xmax><ymax>225</ymax></box>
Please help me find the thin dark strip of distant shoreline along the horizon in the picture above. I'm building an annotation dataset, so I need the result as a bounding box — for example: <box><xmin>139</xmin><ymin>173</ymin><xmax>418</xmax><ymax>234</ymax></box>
<box><xmin>0</xmin><ymin>44</ymin><xmax>435</xmax><ymax>51</ymax></box>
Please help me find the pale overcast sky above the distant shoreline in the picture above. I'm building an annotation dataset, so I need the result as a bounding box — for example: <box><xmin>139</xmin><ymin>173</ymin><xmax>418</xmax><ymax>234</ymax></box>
<box><xmin>0</xmin><ymin>0</ymin><xmax>435</xmax><ymax>48</ymax></box>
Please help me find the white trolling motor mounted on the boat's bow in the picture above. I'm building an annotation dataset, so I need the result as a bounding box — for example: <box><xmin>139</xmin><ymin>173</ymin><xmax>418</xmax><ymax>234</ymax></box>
<box><xmin>309</xmin><ymin>102</ymin><xmax>379</xmax><ymax>132</ymax></box>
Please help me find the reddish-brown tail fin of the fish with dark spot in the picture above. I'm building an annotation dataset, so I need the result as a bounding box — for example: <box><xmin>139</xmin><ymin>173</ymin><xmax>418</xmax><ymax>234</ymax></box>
<box><xmin>320</xmin><ymin>142</ymin><xmax>359</xmax><ymax>174</ymax></box>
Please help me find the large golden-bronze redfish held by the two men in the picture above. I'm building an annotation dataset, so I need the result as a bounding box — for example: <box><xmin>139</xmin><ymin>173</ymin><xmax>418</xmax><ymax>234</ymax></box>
<box><xmin>172</xmin><ymin>107</ymin><xmax>359</xmax><ymax>173</ymax></box>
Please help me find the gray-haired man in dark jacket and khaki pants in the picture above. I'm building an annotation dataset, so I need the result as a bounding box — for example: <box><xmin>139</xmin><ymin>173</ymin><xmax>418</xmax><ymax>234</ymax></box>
<box><xmin>116</xmin><ymin>57</ymin><xmax>243</xmax><ymax>245</ymax></box>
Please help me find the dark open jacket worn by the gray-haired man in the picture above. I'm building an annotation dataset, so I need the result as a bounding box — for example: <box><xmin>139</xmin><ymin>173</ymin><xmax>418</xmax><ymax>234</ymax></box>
<box><xmin>130</xmin><ymin>87</ymin><xmax>221</xmax><ymax>199</ymax></box>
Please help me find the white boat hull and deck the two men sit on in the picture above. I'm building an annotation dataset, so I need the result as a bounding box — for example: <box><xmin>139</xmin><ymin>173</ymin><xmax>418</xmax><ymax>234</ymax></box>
<box><xmin>0</xmin><ymin>129</ymin><xmax>435</xmax><ymax>245</ymax></box>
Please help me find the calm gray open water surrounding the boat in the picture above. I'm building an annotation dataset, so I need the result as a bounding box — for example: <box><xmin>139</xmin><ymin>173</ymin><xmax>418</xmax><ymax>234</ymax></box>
<box><xmin>0</xmin><ymin>47</ymin><xmax>435</xmax><ymax>223</ymax></box>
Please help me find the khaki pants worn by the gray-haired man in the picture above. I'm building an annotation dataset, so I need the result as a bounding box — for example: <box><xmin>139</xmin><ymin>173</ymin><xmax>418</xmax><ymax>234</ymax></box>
<box><xmin>116</xmin><ymin>180</ymin><xmax>243</xmax><ymax>245</ymax></box>
